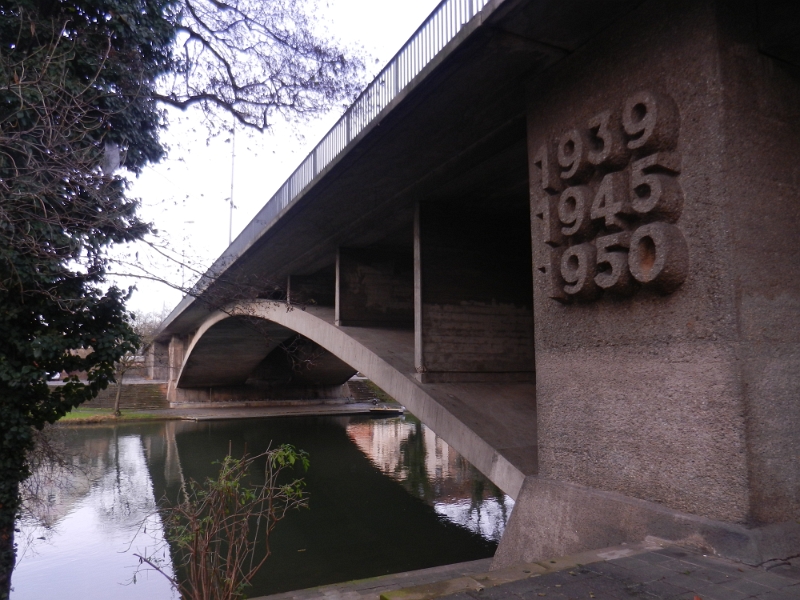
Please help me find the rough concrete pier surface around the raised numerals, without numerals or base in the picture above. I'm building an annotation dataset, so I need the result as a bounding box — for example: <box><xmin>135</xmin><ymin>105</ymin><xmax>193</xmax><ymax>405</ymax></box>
<box><xmin>528</xmin><ymin>1</ymin><xmax>800</xmax><ymax>523</ymax></box>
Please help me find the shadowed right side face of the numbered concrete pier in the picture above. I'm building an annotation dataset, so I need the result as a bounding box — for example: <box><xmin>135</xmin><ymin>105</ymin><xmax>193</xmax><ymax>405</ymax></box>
<box><xmin>718</xmin><ymin>0</ymin><xmax>800</xmax><ymax>523</ymax></box>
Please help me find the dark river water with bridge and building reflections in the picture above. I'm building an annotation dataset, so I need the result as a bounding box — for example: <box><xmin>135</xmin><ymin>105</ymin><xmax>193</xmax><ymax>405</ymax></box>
<box><xmin>11</xmin><ymin>414</ymin><xmax>513</xmax><ymax>600</ymax></box>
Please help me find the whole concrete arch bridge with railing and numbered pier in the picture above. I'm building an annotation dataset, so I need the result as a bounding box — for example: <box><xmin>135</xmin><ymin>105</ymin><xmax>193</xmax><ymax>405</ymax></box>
<box><xmin>152</xmin><ymin>0</ymin><xmax>800</xmax><ymax>565</ymax></box>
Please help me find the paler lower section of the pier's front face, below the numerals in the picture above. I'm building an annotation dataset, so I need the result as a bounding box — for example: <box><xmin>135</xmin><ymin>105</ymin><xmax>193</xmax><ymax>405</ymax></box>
<box><xmin>537</xmin><ymin>344</ymin><xmax>747</xmax><ymax>520</ymax></box>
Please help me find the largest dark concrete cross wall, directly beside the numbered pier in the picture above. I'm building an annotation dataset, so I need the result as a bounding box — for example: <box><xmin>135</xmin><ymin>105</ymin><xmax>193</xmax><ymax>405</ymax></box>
<box><xmin>414</xmin><ymin>204</ymin><xmax>534</xmax><ymax>383</ymax></box>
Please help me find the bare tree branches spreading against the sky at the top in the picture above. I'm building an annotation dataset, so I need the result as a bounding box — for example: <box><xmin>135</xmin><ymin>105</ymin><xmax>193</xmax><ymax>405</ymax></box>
<box><xmin>157</xmin><ymin>0</ymin><xmax>363</xmax><ymax>130</ymax></box>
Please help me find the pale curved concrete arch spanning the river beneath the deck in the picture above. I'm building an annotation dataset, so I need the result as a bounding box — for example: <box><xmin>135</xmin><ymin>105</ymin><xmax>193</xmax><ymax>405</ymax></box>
<box><xmin>176</xmin><ymin>300</ymin><xmax>528</xmax><ymax>498</ymax></box>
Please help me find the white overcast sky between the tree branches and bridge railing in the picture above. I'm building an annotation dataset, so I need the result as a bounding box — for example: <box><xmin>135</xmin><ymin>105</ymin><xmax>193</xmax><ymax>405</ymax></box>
<box><xmin>117</xmin><ymin>0</ymin><xmax>438</xmax><ymax>312</ymax></box>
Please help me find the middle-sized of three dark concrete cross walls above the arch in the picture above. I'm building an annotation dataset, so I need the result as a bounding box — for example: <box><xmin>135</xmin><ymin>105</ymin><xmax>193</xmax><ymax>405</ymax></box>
<box><xmin>335</xmin><ymin>248</ymin><xmax>414</xmax><ymax>329</ymax></box>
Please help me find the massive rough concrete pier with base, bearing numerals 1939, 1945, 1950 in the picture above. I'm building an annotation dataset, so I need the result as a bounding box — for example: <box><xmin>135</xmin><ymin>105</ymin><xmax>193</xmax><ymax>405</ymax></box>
<box><xmin>496</xmin><ymin>1</ymin><xmax>800</xmax><ymax>566</ymax></box>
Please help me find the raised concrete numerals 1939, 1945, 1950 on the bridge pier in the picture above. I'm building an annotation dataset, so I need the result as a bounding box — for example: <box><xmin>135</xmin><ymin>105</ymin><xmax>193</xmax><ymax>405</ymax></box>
<box><xmin>533</xmin><ymin>91</ymin><xmax>689</xmax><ymax>301</ymax></box>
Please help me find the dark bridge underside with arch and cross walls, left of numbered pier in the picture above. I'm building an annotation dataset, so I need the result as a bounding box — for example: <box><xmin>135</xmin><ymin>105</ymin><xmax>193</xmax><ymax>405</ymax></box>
<box><xmin>152</xmin><ymin>2</ymin><xmax>580</xmax><ymax>496</ymax></box>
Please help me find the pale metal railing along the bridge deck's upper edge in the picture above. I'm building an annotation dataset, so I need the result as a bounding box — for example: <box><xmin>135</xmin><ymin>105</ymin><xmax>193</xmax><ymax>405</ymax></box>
<box><xmin>250</xmin><ymin>0</ymin><xmax>491</xmax><ymax>227</ymax></box>
